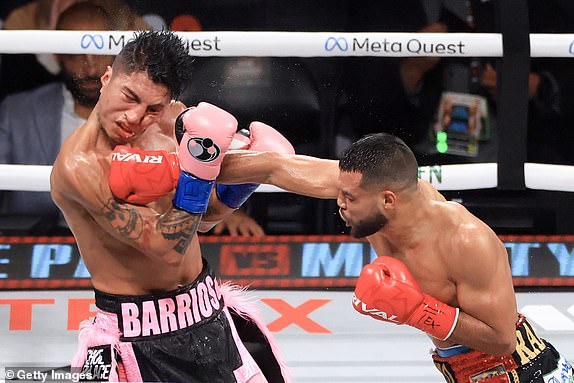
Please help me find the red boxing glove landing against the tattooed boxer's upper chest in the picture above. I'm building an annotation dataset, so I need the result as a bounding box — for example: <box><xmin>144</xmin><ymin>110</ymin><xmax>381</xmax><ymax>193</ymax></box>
<box><xmin>109</xmin><ymin>145</ymin><xmax>179</xmax><ymax>205</ymax></box>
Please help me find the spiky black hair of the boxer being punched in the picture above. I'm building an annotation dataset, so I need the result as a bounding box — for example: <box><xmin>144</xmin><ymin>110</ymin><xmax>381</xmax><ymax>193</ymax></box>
<box><xmin>114</xmin><ymin>31</ymin><xmax>193</xmax><ymax>99</ymax></box>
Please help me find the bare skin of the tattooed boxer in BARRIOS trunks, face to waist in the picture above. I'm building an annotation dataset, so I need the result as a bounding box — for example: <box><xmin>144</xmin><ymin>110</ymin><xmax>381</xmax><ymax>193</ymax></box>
<box><xmin>51</xmin><ymin>68</ymin><xmax>238</xmax><ymax>295</ymax></box>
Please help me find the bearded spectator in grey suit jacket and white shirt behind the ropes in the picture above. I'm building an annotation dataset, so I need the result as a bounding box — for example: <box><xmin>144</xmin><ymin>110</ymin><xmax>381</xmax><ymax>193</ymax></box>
<box><xmin>0</xmin><ymin>2</ymin><xmax>114</xmax><ymax>234</ymax></box>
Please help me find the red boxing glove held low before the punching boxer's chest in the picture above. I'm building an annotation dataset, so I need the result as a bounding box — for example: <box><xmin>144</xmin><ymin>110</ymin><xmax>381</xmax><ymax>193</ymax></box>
<box><xmin>353</xmin><ymin>257</ymin><xmax>459</xmax><ymax>340</ymax></box>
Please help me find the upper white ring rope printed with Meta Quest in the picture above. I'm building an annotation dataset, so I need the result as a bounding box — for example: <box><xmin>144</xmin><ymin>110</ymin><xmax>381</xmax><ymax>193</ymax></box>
<box><xmin>0</xmin><ymin>30</ymin><xmax>574</xmax><ymax>57</ymax></box>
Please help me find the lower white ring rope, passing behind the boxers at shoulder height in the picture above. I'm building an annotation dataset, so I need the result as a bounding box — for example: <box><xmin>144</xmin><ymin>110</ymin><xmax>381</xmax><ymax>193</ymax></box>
<box><xmin>0</xmin><ymin>163</ymin><xmax>574</xmax><ymax>193</ymax></box>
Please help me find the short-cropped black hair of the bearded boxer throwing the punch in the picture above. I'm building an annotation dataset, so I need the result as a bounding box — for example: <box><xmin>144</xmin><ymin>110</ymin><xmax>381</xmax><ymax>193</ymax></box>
<box><xmin>339</xmin><ymin>133</ymin><xmax>418</xmax><ymax>189</ymax></box>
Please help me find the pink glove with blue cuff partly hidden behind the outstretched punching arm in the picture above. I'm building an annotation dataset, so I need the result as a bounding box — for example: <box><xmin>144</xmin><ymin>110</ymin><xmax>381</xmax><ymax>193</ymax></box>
<box><xmin>216</xmin><ymin>121</ymin><xmax>295</xmax><ymax>209</ymax></box>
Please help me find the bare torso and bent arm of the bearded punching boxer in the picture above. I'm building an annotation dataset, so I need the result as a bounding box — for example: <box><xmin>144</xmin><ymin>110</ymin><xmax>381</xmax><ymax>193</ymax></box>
<box><xmin>369</xmin><ymin>181</ymin><xmax>518</xmax><ymax>349</ymax></box>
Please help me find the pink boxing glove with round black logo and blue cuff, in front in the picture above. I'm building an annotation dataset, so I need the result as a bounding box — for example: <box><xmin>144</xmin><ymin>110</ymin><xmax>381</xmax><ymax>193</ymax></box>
<box><xmin>173</xmin><ymin>102</ymin><xmax>237</xmax><ymax>214</ymax></box>
